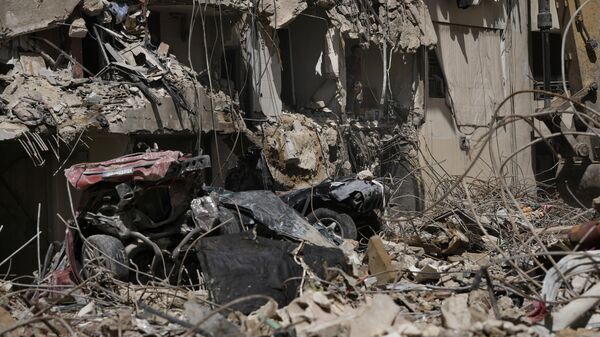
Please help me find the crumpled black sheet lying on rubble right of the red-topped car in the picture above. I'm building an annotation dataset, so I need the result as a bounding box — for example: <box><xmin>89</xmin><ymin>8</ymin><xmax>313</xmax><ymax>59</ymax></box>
<box><xmin>196</xmin><ymin>232</ymin><xmax>347</xmax><ymax>314</ymax></box>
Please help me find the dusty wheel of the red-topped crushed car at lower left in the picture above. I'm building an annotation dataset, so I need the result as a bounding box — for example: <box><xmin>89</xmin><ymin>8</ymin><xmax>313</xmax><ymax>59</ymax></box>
<box><xmin>81</xmin><ymin>234</ymin><xmax>129</xmax><ymax>281</ymax></box>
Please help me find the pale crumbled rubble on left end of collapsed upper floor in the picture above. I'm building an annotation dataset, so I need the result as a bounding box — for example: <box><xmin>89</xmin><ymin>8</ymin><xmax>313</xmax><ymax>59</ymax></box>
<box><xmin>0</xmin><ymin>54</ymin><xmax>149</xmax><ymax>139</ymax></box>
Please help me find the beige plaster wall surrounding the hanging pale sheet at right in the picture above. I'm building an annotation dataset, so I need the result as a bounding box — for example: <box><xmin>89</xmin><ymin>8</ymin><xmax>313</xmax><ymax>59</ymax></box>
<box><xmin>420</xmin><ymin>0</ymin><xmax>534</xmax><ymax>201</ymax></box>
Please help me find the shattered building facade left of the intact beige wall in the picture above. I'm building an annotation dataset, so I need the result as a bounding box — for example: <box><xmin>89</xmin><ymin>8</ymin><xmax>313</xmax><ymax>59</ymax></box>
<box><xmin>0</xmin><ymin>0</ymin><xmax>446</xmax><ymax>266</ymax></box>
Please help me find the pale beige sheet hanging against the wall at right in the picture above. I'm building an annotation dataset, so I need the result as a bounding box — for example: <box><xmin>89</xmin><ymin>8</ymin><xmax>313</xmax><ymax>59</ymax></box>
<box><xmin>435</xmin><ymin>24</ymin><xmax>505</xmax><ymax>126</ymax></box>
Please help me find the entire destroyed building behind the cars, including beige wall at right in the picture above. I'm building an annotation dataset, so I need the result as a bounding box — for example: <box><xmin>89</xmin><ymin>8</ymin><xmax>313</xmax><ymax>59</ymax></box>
<box><xmin>1</xmin><ymin>0</ymin><xmax>535</xmax><ymax>270</ymax></box>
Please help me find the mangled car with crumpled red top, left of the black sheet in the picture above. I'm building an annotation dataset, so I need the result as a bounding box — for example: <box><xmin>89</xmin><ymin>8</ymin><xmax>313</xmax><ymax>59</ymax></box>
<box><xmin>65</xmin><ymin>151</ymin><xmax>210</xmax><ymax>281</ymax></box>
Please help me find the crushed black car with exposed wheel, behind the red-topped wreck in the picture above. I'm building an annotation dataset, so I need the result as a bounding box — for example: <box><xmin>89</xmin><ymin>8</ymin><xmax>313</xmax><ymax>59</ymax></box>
<box><xmin>225</xmin><ymin>146</ymin><xmax>389</xmax><ymax>242</ymax></box>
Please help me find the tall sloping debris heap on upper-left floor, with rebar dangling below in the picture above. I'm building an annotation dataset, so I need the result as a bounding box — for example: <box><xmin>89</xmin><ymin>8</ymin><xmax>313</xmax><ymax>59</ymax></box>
<box><xmin>0</xmin><ymin>0</ymin><xmax>239</xmax><ymax>165</ymax></box>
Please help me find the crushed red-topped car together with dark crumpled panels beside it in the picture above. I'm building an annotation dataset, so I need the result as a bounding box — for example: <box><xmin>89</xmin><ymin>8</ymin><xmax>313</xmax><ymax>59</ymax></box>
<box><xmin>43</xmin><ymin>150</ymin><xmax>346</xmax><ymax>310</ymax></box>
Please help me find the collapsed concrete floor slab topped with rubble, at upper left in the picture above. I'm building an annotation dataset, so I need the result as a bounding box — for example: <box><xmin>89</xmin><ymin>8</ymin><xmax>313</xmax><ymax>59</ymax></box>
<box><xmin>0</xmin><ymin>36</ymin><xmax>239</xmax><ymax>139</ymax></box>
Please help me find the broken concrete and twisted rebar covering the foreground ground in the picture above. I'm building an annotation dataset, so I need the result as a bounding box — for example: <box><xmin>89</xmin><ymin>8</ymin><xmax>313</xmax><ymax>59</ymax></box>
<box><xmin>0</xmin><ymin>175</ymin><xmax>600</xmax><ymax>337</ymax></box>
